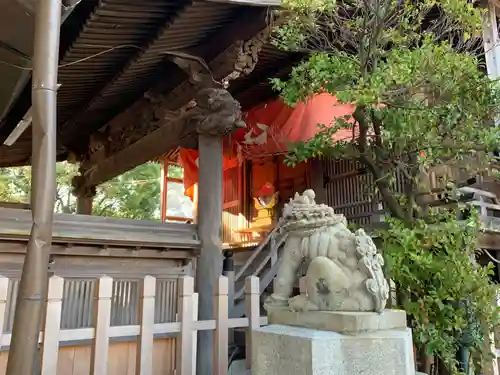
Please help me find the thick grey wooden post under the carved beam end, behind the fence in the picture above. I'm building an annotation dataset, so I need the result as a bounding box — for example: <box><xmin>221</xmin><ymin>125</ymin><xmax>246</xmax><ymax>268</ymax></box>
<box><xmin>196</xmin><ymin>133</ymin><xmax>223</xmax><ymax>375</ymax></box>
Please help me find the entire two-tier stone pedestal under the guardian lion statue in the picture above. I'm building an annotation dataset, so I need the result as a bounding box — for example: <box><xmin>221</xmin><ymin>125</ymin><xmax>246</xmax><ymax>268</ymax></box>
<box><xmin>252</xmin><ymin>310</ymin><xmax>415</xmax><ymax>375</ymax></box>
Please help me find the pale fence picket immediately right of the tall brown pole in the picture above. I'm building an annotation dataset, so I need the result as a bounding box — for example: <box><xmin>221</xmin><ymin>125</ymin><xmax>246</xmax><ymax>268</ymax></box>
<box><xmin>41</xmin><ymin>276</ymin><xmax>64</xmax><ymax>375</ymax></box>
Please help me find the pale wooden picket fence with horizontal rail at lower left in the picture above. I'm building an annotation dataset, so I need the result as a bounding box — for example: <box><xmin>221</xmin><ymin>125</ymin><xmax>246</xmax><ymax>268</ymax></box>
<box><xmin>0</xmin><ymin>276</ymin><xmax>267</xmax><ymax>375</ymax></box>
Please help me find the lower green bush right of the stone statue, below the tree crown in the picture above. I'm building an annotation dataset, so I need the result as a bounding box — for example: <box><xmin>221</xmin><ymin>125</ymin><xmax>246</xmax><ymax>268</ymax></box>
<box><xmin>380</xmin><ymin>212</ymin><xmax>499</xmax><ymax>371</ymax></box>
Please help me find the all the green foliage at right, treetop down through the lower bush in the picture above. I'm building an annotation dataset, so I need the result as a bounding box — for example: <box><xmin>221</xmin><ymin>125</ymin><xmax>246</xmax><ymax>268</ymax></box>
<box><xmin>272</xmin><ymin>0</ymin><xmax>500</xmax><ymax>371</ymax></box>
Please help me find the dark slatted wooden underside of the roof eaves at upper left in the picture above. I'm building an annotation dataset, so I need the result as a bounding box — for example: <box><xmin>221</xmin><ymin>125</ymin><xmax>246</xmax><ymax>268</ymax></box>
<box><xmin>0</xmin><ymin>0</ymin><xmax>296</xmax><ymax>167</ymax></box>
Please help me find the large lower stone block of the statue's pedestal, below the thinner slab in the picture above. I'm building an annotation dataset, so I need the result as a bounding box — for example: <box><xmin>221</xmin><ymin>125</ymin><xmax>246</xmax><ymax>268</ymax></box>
<box><xmin>252</xmin><ymin>324</ymin><xmax>415</xmax><ymax>375</ymax></box>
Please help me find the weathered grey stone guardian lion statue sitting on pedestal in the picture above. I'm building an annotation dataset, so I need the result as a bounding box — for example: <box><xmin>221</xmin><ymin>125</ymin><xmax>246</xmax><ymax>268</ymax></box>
<box><xmin>265</xmin><ymin>190</ymin><xmax>389</xmax><ymax>312</ymax></box>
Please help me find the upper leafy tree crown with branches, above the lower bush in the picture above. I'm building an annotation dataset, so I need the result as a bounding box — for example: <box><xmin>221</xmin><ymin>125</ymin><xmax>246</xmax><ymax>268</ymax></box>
<box><xmin>273</xmin><ymin>0</ymin><xmax>500</xmax><ymax>221</ymax></box>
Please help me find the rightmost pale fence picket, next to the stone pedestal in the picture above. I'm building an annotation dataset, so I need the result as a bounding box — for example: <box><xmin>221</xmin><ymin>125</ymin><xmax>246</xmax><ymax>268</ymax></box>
<box><xmin>245</xmin><ymin>276</ymin><xmax>260</xmax><ymax>369</ymax></box>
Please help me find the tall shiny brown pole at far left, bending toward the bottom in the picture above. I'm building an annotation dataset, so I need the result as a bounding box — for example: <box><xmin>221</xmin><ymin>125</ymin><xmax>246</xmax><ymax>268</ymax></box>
<box><xmin>6</xmin><ymin>0</ymin><xmax>61</xmax><ymax>375</ymax></box>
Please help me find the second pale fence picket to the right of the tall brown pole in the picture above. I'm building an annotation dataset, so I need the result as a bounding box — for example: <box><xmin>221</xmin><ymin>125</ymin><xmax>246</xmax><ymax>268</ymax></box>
<box><xmin>90</xmin><ymin>276</ymin><xmax>113</xmax><ymax>375</ymax></box>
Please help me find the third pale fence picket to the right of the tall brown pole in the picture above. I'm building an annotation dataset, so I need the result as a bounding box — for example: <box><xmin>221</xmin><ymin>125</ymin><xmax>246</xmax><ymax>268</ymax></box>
<box><xmin>136</xmin><ymin>276</ymin><xmax>156</xmax><ymax>375</ymax></box>
